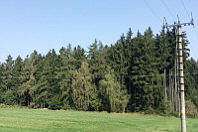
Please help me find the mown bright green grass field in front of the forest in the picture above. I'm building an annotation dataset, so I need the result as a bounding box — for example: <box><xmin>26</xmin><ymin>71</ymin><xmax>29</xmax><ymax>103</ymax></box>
<box><xmin>0</xmin><ymin>108</ymin><xmax>198</xmax><ymax>132</ymax></box>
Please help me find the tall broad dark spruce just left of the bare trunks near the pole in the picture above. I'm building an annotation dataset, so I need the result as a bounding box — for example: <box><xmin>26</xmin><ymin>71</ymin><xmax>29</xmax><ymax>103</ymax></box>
<box><xmin>131</xmin><ymin>28</ymin><xmax>162</xmax><ymax>111</ymax></box>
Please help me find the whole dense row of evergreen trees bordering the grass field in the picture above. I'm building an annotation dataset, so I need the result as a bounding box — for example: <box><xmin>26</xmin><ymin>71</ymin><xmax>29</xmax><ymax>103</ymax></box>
<box><xmin>0</xmin><ymin>28</ymin><xmax>198</xmax><ymax>113</ymax></box>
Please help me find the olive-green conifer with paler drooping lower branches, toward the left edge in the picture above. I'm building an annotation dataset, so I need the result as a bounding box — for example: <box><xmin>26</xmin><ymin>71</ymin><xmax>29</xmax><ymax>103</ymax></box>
<box><xmin>17</xmin><ymin>51</ymin><xmax>43</xmax><ymax>108</ymax></box>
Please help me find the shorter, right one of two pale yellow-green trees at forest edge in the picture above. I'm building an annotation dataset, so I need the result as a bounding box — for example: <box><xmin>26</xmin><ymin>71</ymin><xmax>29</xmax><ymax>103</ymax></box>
<box><xmin>99</xmin><ymin>71</ymin><xmax>129</xmax><ymax>112</ymax></box>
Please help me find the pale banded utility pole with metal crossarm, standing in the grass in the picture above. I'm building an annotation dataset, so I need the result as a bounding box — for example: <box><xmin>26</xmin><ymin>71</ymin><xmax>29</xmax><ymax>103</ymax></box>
<box><xmin>166</xmin><ymin>14</ymin><xmax>194</xmax><ymax>132</ymax></box>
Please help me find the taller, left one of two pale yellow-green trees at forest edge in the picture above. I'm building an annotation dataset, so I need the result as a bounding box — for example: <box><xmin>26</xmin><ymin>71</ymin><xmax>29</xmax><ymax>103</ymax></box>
<box><xmin>71</xmin><ymin>62</ymin><xmax>97</xmax><ymax>110</ymax></box>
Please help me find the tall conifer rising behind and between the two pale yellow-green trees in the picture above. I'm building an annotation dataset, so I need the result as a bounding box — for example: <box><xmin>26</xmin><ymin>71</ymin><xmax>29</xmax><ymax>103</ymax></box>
<box><xmin>88</xmin><ymin>40</ymin><xmax>109</xmax><ymax>111</ymax></box>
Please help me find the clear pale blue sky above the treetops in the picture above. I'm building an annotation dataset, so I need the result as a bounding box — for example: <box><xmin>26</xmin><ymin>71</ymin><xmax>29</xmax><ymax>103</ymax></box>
<box><xmin>0</xmin><ymin>0</ymin><xmax>198</xmax><ymax>62</ymax></box>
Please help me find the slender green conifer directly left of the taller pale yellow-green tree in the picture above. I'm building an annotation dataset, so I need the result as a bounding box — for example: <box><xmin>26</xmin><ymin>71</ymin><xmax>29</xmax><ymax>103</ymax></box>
<box><xmin>57</xmin><ymin>44</ymin><xmax>76</xmax><ymax>109</ymax></box>
